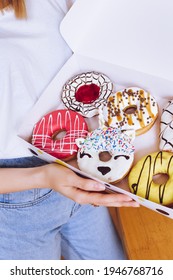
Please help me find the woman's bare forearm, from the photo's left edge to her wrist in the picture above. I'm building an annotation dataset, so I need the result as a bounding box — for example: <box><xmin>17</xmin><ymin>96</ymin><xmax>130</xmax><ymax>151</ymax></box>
<box><xmin>0</xmin><ymin>166</ymin><xmax>49</xmax><ymax>193</ymax></box>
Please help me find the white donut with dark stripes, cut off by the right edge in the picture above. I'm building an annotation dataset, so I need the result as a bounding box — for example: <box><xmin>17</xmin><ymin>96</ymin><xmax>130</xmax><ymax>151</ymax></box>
<box><xmin>160</xmin><ymin>100</ymin><xmax>173</xmax><ymax>152</ymax></box>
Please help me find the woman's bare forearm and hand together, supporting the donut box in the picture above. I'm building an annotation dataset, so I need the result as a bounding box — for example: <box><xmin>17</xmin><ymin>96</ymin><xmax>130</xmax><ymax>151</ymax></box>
<box><xmin>0</xmin><ymin>163</ymin><xmax>139</xmax><ymax>207</ymax></box>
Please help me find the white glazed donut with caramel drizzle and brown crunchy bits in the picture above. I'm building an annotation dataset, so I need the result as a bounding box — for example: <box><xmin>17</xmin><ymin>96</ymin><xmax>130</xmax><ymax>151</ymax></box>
<box><xmin>99</xmin><ymin>87</ymin><xmax>158</xmax><ymax>135</ymax></box>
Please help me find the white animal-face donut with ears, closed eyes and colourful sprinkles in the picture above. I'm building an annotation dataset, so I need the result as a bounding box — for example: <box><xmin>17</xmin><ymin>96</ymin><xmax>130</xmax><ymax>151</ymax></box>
<box><xmin>76</xmin><ymin>127</ymin><xmax>135</xmax><ymax>182</ymax></box>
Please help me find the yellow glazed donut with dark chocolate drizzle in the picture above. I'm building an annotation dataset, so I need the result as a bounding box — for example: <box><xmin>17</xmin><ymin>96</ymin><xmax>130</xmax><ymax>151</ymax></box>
<box><xmin>128</xmin><ymin>151</ymin><xmax>173</xmax><ymax>206</ymax></box>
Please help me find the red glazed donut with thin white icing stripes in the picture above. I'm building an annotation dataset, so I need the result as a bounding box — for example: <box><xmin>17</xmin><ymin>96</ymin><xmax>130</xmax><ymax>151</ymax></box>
<box><xmin>32</xmin><ymin>109</ymin><xmax>88</xmax><ymax>161</ymax></box>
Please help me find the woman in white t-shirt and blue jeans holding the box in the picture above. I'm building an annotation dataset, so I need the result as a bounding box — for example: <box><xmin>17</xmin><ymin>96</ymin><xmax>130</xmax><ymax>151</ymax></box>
<box><xmin>0</xmin><ymin>0</ymin><xmax>138</xmax><ymax>259</ymax></box>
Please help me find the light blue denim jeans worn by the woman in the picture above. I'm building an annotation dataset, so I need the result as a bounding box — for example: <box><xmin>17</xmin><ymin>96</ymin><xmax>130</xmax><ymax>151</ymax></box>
<box><xmin>0</xmin><ymin>157</ymin><xmax>125</xmax><ymax>260</ymax></box>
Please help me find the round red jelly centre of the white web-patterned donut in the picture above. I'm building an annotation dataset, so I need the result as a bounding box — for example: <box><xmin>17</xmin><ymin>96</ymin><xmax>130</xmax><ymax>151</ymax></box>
<box><xmin>75</xmin><ymin>84</ymin><xmax>100</xmax><ymax>104</ymax></box>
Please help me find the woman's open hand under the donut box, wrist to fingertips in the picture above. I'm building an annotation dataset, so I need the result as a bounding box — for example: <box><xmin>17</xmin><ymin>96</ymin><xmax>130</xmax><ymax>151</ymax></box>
<box><xmin>43</xmin><ymin>163</ymin><xmax>139</xmax><ymax>207</ymax></box>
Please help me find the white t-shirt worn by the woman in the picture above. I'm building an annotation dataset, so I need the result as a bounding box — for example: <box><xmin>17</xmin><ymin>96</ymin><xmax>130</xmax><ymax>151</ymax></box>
<box><xmin>0</xmin><ymin>0</ymin><xmax>74</xmax><ymax>159</ymax></box>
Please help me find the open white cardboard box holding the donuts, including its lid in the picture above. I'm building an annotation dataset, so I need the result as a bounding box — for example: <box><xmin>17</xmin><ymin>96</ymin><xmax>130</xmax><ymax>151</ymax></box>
<box><xmin>19</xmin><ymin>0</ymin><xmax>173</xmax><ymax>218</ymax></box>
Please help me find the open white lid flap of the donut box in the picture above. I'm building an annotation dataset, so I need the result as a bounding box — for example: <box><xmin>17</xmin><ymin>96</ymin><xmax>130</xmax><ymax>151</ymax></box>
<box><xmin>61</xmin><ymin>0</ymin><xmax>173</xmax><ymax>81</ymax></box>
